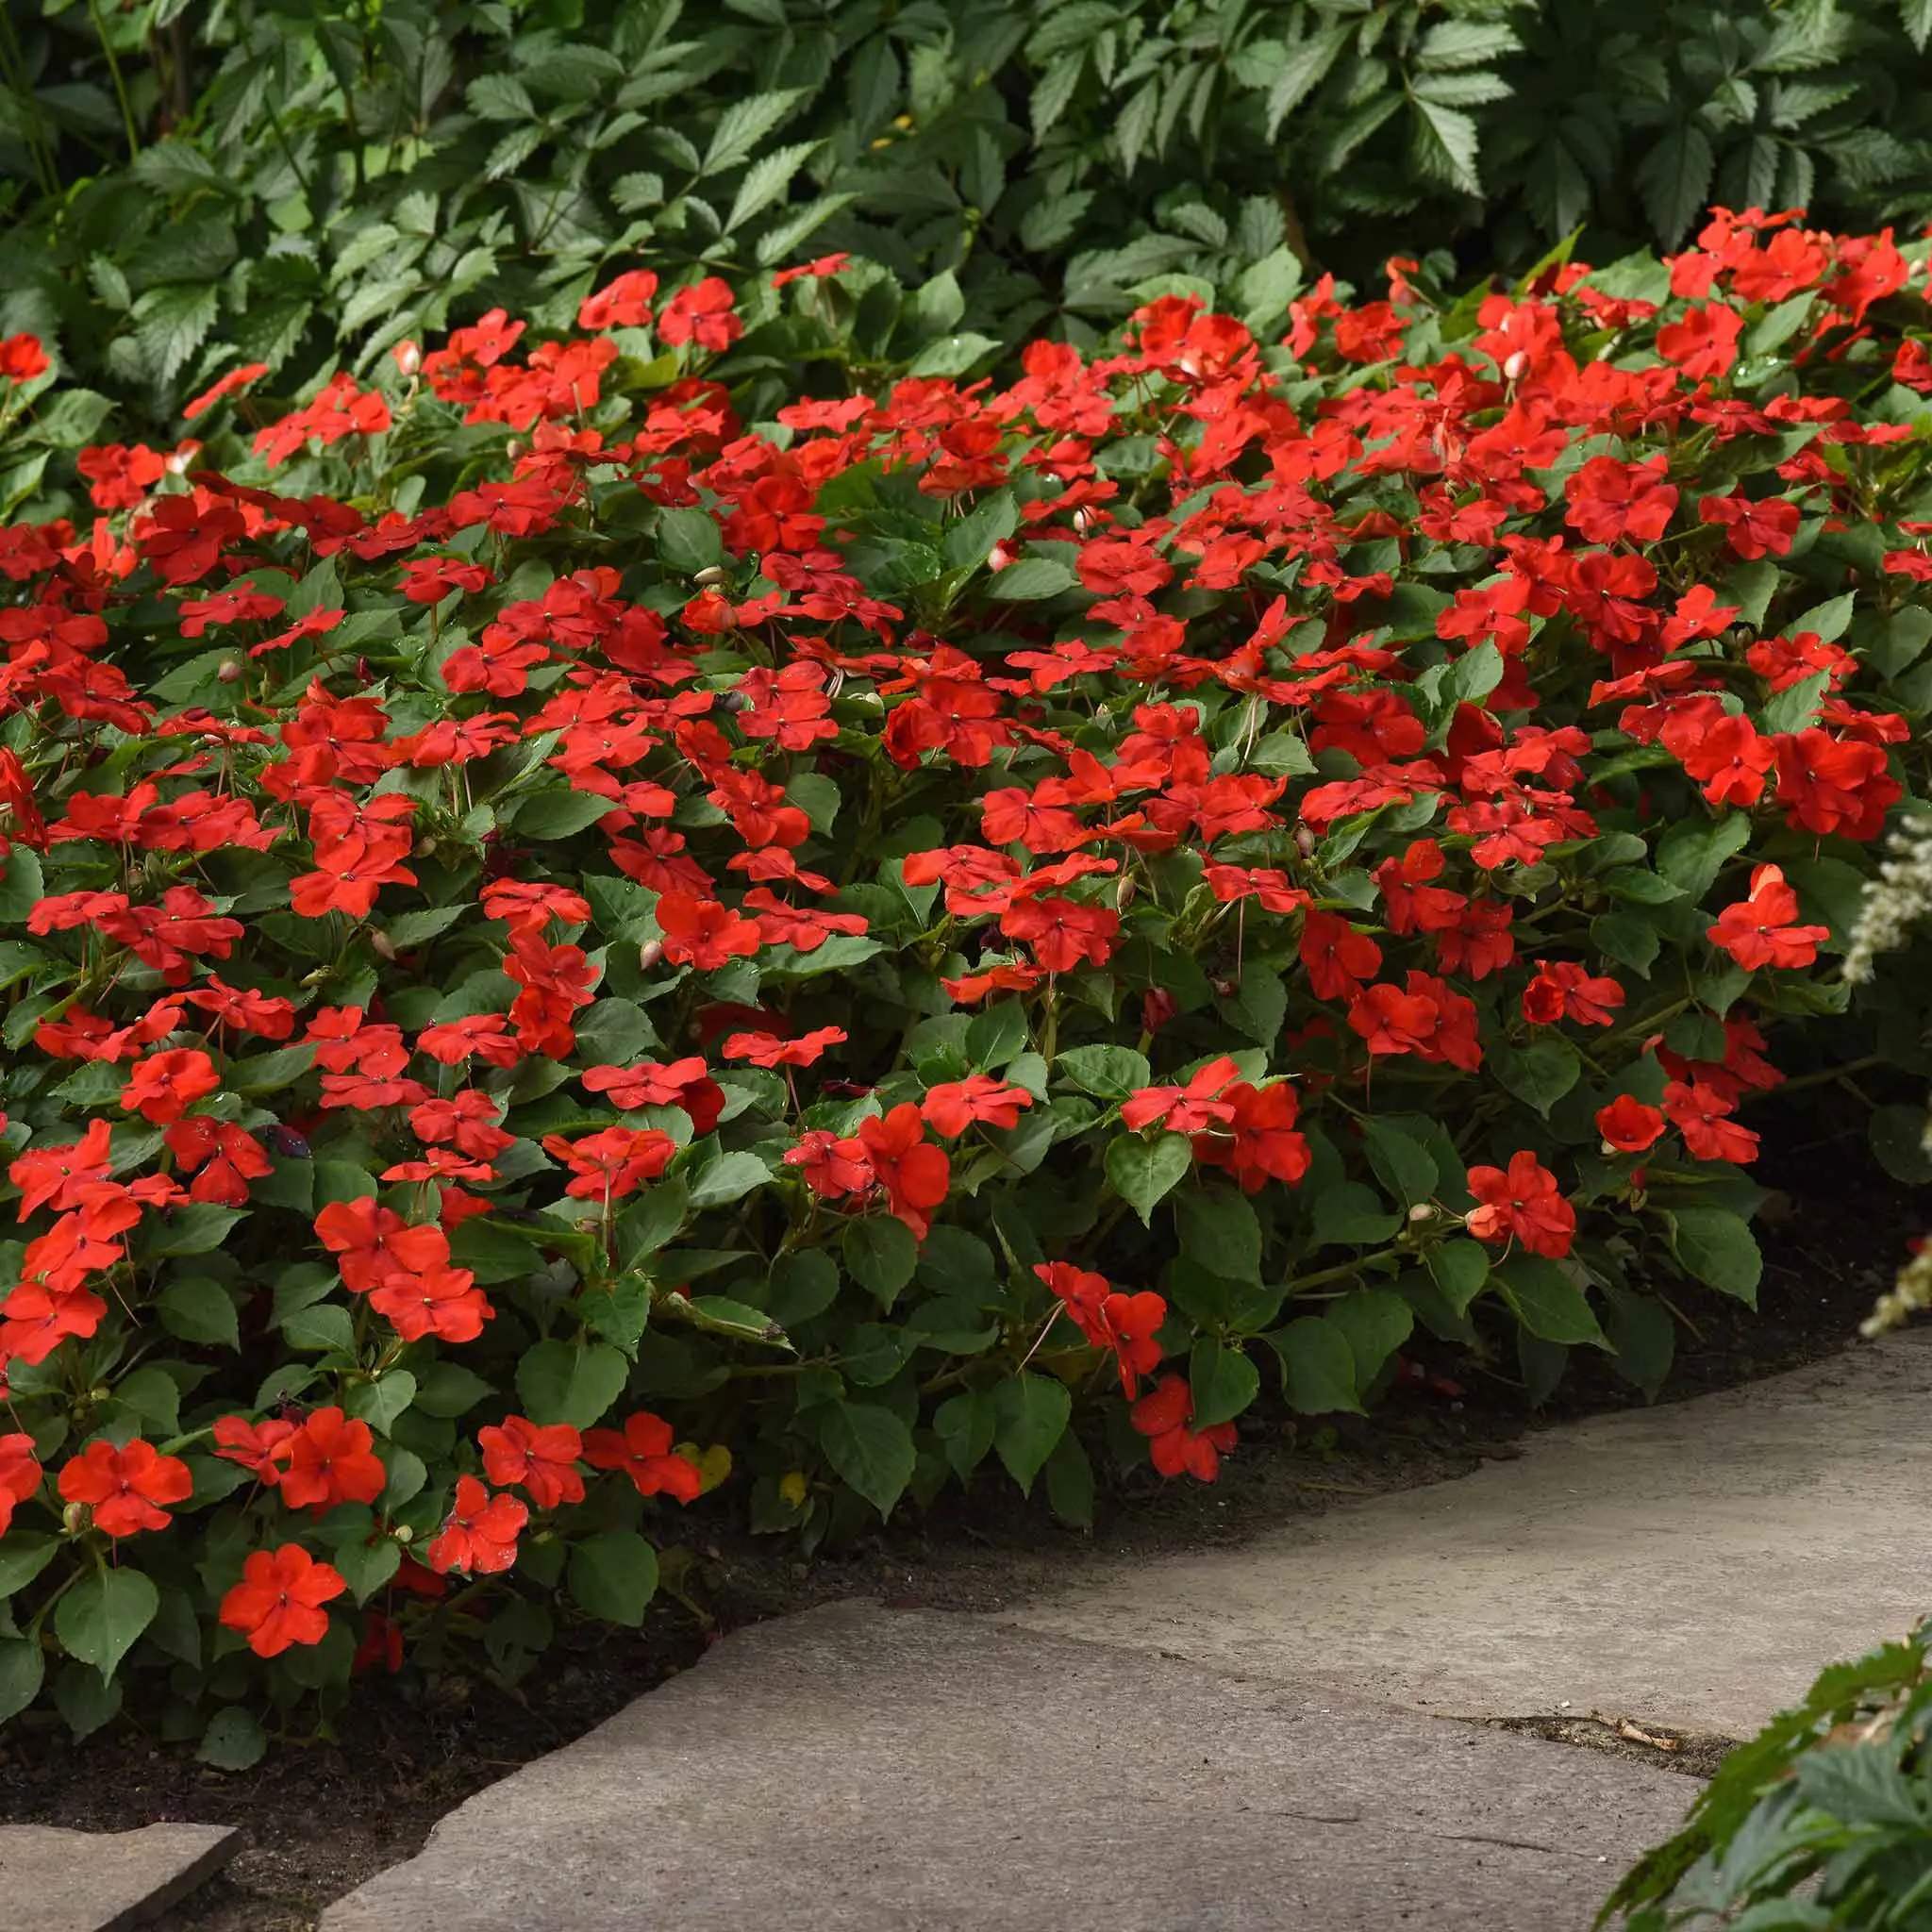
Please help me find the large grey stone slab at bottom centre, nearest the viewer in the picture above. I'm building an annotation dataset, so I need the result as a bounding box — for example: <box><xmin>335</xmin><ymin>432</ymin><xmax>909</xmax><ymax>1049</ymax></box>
<box><xmin>321</xmin><ymin>1604</ymin><xmax>1694</xmax><ymax>1932</ymax></box>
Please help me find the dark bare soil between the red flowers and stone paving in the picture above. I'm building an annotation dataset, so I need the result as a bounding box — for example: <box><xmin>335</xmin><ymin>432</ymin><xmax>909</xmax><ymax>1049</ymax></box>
<box><xmin>0</xmin><ymin>1095</ymin><xmax>1923</xmax><ymax>1932</ymax></box>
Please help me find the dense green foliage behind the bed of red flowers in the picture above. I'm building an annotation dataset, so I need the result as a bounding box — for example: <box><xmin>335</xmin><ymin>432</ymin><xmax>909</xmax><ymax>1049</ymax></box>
<box><xmin>15</xmin><ymin>0</ymin><xmax>1932</xmax><ymax>426</ymax></box>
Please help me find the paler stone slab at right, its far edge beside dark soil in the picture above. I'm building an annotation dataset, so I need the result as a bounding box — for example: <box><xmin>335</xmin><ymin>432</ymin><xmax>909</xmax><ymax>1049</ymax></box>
<box><xmin>1010</xmin><ymin>1329</ymin><xmax>1932</xmax><ymax>1737</ymax></box>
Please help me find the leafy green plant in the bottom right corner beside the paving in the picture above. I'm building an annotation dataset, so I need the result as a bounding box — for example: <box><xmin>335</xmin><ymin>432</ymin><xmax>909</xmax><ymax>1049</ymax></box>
<box><xmin>1598</xmin><ymin>1626</ymin><xmax>1932</xmax><ymax>1932</ymax></box>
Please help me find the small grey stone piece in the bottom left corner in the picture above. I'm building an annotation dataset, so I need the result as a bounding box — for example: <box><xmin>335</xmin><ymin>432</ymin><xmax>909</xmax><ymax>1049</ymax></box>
<box><xmin>0</xmin><ymin>1824</ymin><xmax>242</xmax><ymax>1932</ymax></box>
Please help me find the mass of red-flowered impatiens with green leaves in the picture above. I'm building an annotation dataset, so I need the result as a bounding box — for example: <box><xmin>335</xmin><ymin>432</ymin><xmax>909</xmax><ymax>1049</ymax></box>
<box><xmin>0</xmin><ymin>204</ymin><xmax>1932</xmax><ymax>1764</ymax></box>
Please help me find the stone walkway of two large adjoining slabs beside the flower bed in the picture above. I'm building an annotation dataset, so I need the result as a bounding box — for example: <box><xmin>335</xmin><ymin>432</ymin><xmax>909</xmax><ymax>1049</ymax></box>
<box><xmin>323</xmin><ymin>1335</ymin><xmax>1932</xmax><ymax>1932</ymax></box>
